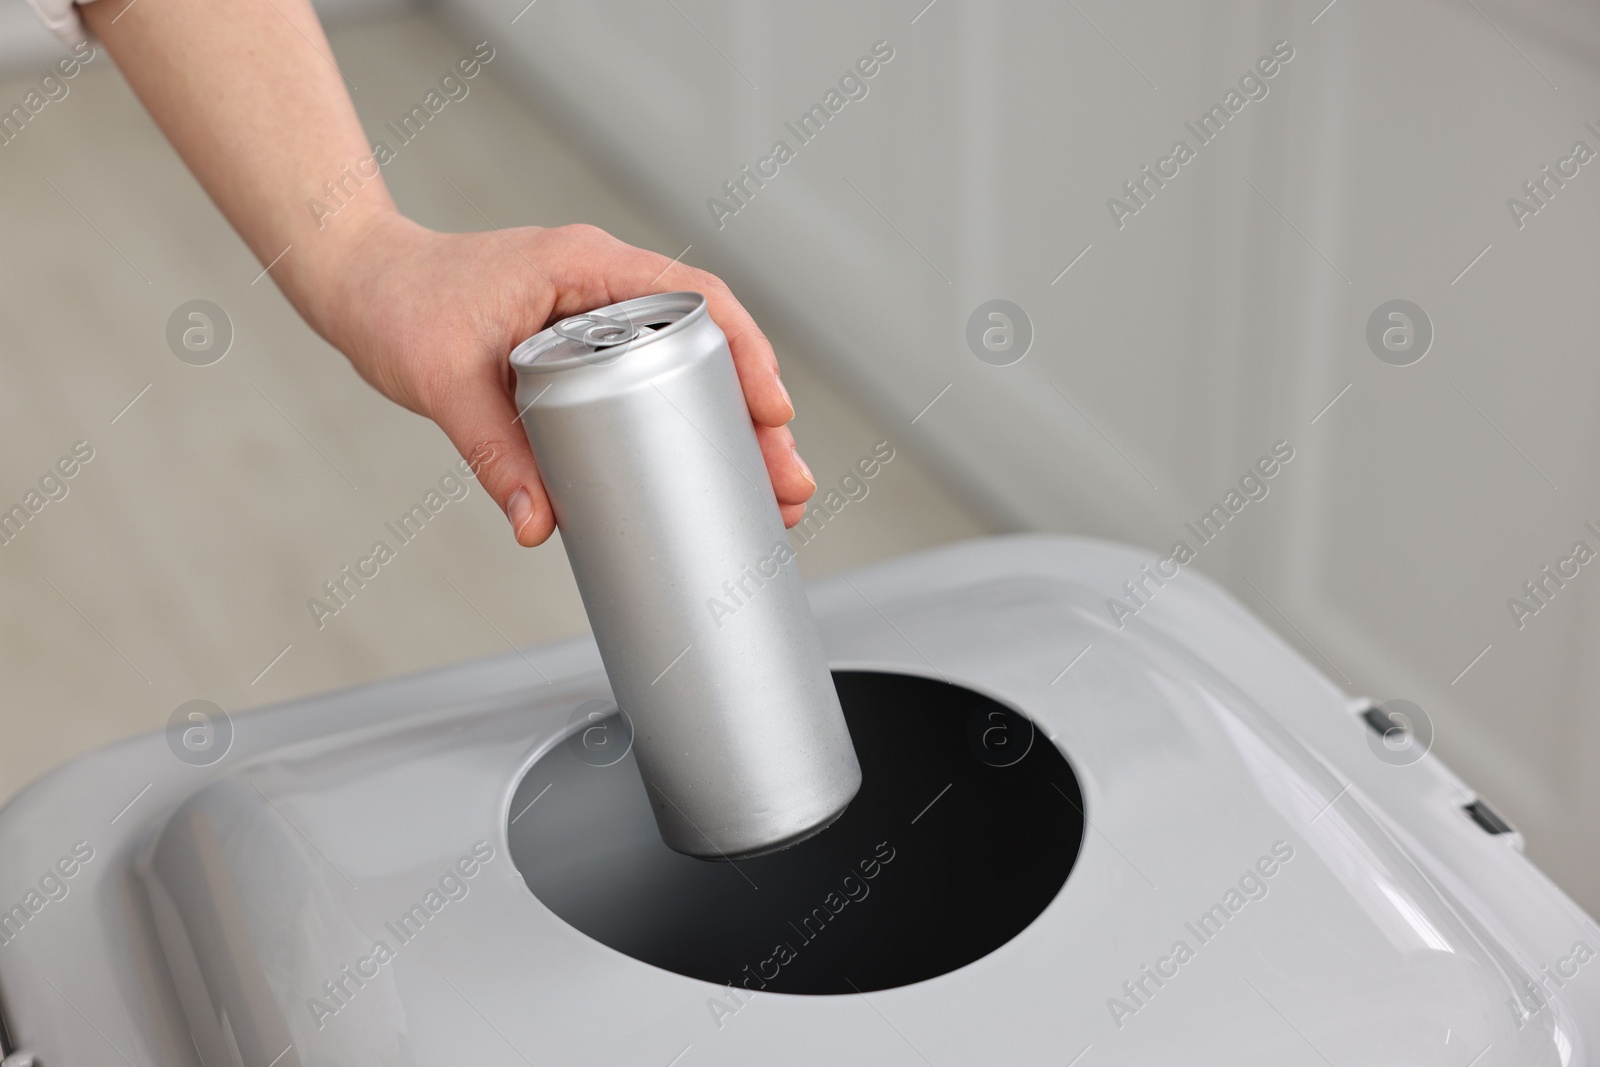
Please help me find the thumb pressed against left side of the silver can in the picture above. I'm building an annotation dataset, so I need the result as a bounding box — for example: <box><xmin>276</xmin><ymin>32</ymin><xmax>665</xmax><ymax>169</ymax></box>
<box><xmin>427</xmin><ymin>360</ymin><xmax>555</xmax><ymax>549</ymax></box>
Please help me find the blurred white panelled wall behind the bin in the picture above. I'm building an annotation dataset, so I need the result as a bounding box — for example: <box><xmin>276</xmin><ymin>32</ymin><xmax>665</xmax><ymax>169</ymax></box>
<box><xmin>435</xmin><ymin>0</ymin><xmax>1600</xmax><ymax>910</ymax></box>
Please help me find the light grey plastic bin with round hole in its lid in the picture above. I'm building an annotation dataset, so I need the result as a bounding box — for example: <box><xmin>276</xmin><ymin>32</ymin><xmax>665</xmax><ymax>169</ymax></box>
<box><xmin>0</xmin><ymin>537</ymin><xmax>1600</xmax><ymax>1067</ymax></box>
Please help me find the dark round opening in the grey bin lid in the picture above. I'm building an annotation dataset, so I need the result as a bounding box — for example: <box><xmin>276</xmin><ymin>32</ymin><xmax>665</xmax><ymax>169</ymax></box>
<box><xmin>509</xmin><ymin>672</ymin><xmax>1083</xmax><ymax>993</ymax></box>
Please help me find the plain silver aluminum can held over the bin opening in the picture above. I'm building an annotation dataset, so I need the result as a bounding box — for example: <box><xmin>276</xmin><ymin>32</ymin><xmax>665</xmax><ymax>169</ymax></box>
<box><xmin>510</xmin><ymin>293</ymin><xmax>861</xmax><ymax>859</ymax></box>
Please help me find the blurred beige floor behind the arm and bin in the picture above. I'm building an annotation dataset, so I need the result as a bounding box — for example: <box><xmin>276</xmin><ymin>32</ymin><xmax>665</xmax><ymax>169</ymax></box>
<box><xmin>0</xmin><ymin>14</ymin><xmax>987</xmax><ymax>809</ymax></box>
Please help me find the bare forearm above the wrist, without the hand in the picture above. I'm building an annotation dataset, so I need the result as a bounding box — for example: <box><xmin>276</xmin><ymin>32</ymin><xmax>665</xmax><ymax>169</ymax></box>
<box><xmin>83</xmin><ymin>0</ymin><xmax>394</xmax><ymax>336</ymax></box>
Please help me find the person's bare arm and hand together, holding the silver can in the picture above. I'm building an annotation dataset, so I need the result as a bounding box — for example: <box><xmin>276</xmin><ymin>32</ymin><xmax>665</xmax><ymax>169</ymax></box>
<box><xmin>80</xmin><ymin>0</ymin><xmax>816</xmax><ymax>545</ymax></box>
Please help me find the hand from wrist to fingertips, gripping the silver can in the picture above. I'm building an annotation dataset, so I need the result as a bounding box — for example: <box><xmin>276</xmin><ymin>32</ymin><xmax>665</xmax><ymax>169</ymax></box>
<box><xmin>304</xmin><ymin>211</ymin><xmax>816</xmax><ymax>545</ymax></box>
